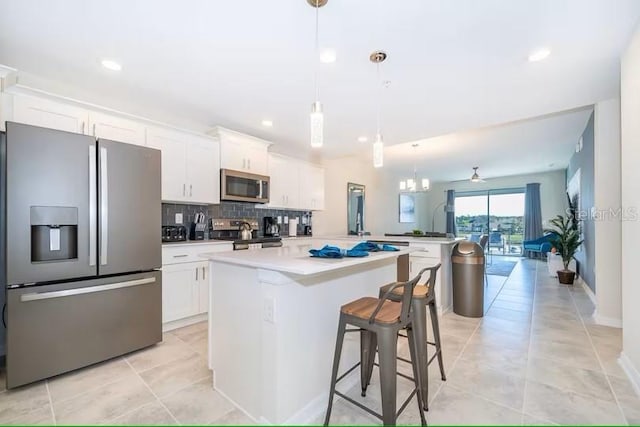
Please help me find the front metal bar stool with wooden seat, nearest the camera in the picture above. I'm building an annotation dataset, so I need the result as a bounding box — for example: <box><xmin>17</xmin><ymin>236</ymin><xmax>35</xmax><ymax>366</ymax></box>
<box><xmin>324</xmin><ymin>270</ymin><xmax>427</xmax><ymax>425</ymax></box>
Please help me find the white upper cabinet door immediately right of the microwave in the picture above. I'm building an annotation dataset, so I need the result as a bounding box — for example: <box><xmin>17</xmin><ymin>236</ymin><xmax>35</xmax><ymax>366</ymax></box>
<box><xmin>269</xmin><ymin>154</ymin><xmax>300</xmax><ymax>209</ymax></box>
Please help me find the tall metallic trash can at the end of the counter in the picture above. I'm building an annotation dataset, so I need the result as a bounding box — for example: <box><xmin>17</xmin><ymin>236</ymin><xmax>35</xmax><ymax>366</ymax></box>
<box><xmin>451</xmin><ymin>240</ymin><xmax>484</xmax><ymax>317</ymax></box>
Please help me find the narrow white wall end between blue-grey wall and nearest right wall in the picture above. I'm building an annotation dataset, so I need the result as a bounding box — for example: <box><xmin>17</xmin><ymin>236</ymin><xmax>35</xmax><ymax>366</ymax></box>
<box><xmin>593</xmin><ymin>99</ymin><xmax>622</xmax><ymax>327</ymax></box>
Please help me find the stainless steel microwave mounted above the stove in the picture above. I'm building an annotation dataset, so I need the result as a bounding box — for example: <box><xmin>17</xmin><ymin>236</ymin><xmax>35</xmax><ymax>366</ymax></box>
<box><xmin>220</xmin><ymin>169</ymin><xmax>269</xmax><ymax>203</ymax></box>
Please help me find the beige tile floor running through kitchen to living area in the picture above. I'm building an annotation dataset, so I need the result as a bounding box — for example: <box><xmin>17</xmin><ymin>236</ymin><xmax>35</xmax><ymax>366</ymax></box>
<box><xmin>0</xmin><ymin>260</ymin><xmax>640</xmax><ymax>425</ymax></box>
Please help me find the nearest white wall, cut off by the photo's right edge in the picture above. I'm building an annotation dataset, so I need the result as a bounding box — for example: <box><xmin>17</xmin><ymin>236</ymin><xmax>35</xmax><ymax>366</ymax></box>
<box><xmin>620</xmin><ymin>21</ymin><xmax>640</xmax><ymax>391</ymax></box>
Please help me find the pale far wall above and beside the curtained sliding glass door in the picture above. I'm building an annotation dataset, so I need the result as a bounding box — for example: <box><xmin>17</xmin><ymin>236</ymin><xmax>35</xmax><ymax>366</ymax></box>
<box><xmin>428</xmin><ymin>170</ymin><xmax>568</xmax><ymax>231</ymax></box>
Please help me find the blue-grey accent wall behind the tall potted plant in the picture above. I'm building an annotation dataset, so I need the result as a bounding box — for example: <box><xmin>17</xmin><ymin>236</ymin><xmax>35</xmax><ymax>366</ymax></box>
<box><xmin>567</xmin><ymin>113</ymin><xmax>596</xmax><ymax>293</ymax></box>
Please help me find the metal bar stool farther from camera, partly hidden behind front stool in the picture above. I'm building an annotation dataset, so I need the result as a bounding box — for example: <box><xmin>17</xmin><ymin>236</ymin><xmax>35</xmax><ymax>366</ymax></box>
<box><xmin>362</xmin><ymin>264</ymin><xmax>447</xmax><ymax>411</ymax></box>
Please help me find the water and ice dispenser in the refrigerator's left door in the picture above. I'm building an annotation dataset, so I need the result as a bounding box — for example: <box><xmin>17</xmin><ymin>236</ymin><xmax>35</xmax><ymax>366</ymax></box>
<box><xmin>31</xmin><ymin>206</ymin><xmax>78</xmax><ymax>262</ymax></box>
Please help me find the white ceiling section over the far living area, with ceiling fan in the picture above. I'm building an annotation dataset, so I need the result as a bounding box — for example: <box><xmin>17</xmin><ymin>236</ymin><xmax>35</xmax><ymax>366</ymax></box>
<box><xmin>385</xmin><ymin>108</ymin><xmax>593</xmax><ymax>182</ymax></box>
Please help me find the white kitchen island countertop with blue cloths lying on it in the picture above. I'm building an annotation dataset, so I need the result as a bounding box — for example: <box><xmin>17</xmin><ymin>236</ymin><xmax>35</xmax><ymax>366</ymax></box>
<box><xmin>200</xmin><ymin>239</ymin><xmax>420</xmax><ymax>276</ymax></box>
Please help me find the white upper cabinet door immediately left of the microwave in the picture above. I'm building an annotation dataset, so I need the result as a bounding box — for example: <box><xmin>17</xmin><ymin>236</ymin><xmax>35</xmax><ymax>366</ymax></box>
<box><xmin>187</xmin><ymin>136</ymin><xmax>220</xmax><ymax>204</ymax></box>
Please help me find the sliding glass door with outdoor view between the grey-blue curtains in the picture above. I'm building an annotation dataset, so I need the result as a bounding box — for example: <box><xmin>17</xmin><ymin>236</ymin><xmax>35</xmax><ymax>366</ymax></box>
<box><xmin>455</xmin><ymin>188</ymin><xmax>524</xmax><ymax>256</ymax></box>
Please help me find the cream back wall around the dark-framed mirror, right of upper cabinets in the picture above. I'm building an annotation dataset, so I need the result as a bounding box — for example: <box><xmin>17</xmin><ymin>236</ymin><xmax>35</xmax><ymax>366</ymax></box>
<box><xmin>313</xmin><ymin>156</ymin><xmax>429</xmax><ymax>236</ymax></box>
